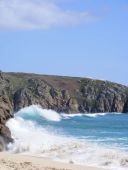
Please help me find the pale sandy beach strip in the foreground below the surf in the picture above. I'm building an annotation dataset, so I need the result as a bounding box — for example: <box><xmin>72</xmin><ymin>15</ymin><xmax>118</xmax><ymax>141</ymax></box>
<box><xmin>0</xmin><ymin>152</ymin><xmax>107</xmax><ymax>170</ymax></box>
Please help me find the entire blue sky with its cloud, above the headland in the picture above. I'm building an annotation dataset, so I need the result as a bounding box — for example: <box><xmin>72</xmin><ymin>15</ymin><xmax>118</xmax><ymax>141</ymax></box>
<box><xmin>0</xmin><ymin>0</ymin><xmax>128</xmax><ymax>85</ymax></box>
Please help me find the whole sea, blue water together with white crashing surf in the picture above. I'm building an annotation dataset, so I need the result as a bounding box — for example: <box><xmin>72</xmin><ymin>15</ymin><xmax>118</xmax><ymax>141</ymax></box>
<box><xmin>7</xmin><ymin>105</ymin><xmax>128</xmax><ymax>170</ymax></box>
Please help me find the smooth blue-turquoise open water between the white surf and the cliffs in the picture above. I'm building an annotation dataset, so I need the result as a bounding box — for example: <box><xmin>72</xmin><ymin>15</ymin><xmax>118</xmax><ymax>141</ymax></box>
<box><xmin>56</xmin><ymin>114</ymin><xmax>128</xmax><ymax>150</ymax></box>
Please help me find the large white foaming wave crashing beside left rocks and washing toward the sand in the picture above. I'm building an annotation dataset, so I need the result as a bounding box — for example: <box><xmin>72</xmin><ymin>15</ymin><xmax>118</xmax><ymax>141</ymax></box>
<box><xmin>7</xmin><ymin>106</ymin><xmax>128</xmax><ymax>170</ymax></box>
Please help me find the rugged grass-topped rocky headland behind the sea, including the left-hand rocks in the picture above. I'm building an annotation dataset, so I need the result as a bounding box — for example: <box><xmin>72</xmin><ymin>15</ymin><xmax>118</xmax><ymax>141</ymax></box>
<box><xmin>0</xmin><ymin>73</ymin><xmax>128</xmax><ymax>150</ymax></box>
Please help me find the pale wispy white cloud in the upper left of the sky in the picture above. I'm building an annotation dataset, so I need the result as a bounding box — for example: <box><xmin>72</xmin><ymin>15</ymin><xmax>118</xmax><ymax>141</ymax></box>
<box><xmin>0</xmin><ymin>0</ymin><xmax>96</xmax><ymax>30</ymax></box>
